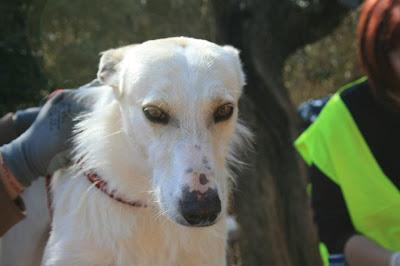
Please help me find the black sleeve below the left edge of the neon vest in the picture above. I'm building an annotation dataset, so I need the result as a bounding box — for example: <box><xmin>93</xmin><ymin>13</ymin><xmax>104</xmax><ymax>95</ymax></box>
<box><xmin>309</xmin><ymin>165</ymin><xmax>355</xmax><ymax>254</ymax></box>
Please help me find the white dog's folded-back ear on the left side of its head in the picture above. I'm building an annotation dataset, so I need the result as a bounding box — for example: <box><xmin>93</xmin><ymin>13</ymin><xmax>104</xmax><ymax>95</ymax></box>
<box><xmin>97</xmin><ymin>44</ymin><xmax>135</xmax><ymax>98</ymax></box>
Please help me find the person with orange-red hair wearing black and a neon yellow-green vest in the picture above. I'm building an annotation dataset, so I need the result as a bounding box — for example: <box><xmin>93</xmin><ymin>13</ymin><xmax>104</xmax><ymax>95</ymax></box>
<box><xmin>295</xmin><ymin>0</ymin><xmax>400</xmax><ymax>266</ymax></box>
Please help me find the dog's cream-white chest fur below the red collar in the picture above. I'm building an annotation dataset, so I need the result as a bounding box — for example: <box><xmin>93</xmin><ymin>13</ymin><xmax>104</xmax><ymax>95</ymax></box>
<box><xmin>44</xmin><ymin>170</ymin><xmax>226</xmax><ymax>266</ymax></box>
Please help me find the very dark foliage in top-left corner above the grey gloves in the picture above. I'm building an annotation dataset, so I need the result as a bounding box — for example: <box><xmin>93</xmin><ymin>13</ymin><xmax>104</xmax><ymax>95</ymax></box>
<box><xmin>0</xmin><ymin>0</ymin><xmax>46</xmax><ymax>115</ymax></box>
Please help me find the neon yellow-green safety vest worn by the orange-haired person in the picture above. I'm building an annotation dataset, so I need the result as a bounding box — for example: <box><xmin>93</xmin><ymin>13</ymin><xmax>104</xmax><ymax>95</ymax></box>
<box><xmin>295</xmin><ymin>90</ymin><xmax>400</xmax><ymax>250</ymax></box>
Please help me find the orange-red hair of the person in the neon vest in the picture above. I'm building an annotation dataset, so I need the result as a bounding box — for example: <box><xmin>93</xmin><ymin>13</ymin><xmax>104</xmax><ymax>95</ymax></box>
<box><xmin>357</xmin><ymin>0</ymin><xmax>400</xmax><ymax>105</ymax></box>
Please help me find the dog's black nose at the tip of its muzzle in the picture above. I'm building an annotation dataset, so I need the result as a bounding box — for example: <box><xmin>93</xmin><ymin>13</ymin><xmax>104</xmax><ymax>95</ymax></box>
<box><xmin>179</xmin><ymin>187</ymin><xmax>221</xmax><ymax>226</ymax></box>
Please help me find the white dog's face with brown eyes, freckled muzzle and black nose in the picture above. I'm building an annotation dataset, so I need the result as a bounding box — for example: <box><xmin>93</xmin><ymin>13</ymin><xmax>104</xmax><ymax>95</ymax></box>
<box><xmin>98</xmin><ymin>38</ymin><xmax>244</xmax><ymax>226</ymax></box>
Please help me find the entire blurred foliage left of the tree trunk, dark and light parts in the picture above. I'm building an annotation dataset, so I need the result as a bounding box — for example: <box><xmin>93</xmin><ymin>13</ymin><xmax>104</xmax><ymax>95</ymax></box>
<box><xmin>0</xmin><ymin>0</ymin><xmax>215</xmax><ymax>115</ymax></box>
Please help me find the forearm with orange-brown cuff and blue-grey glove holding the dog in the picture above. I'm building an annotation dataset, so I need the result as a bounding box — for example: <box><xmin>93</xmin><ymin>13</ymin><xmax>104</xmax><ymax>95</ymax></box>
<box><xmin>0</xmin><ymin>90</ymin><xmax>89</xmax><ymax>236</ymax></box>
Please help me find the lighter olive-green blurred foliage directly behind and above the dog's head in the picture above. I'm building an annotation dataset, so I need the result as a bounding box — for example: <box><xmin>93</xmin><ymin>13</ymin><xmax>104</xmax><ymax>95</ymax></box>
<box><xmin>38</xmin><ymin>0</ymin><xmax>214</xmax><ymax>87</ymax></box>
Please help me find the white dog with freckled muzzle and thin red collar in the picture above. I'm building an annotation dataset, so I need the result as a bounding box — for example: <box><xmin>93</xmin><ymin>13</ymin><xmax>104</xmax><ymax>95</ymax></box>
<box><xmin>3</xmin><ymin>37</ymin><xmax>249</xmax><ymax>266</ymax></box>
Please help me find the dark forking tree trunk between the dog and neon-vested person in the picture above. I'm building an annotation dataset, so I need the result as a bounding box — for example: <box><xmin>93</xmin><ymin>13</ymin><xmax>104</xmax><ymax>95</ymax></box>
<box><xmin>212</xmin><ymin>0</ymin><xmax>354</xmax><ymax>266</ymax></box>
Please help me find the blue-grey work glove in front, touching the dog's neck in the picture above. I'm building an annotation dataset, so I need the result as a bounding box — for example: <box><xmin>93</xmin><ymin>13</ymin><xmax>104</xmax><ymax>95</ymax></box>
<box><xmin>0</xmin><ymin>90</ymin><xmax>89</xmax><ymax>186</ymax></box>
